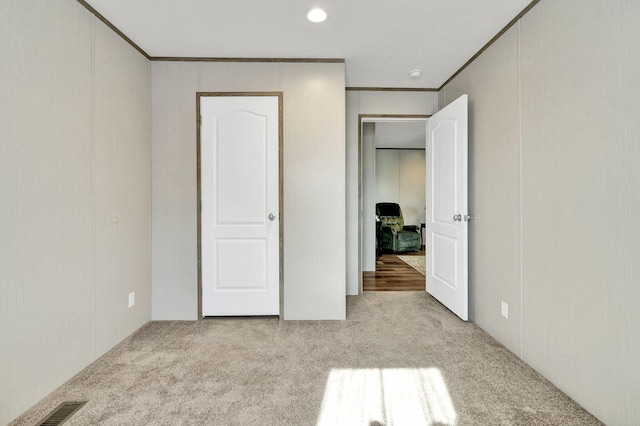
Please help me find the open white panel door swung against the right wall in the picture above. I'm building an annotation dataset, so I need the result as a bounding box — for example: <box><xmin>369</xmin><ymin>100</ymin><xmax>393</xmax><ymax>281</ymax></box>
<box><xmin>426</xmin><ymin>95</ymin><xmax>471</xmax><ymax>321</ymax></box>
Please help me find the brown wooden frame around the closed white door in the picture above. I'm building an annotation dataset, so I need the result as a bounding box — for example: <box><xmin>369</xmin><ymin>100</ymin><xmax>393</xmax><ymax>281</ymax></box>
<box><xmin>196</xmin><ymin>92</ymin><xmax>285</xmax><ymax>321</ymax></box>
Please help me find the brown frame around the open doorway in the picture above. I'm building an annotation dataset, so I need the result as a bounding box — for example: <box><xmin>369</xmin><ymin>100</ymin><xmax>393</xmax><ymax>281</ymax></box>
<box><xmin>358</xmin><ymin>114</ymin><xmax>431</xmax><ymax>295</ymax></box>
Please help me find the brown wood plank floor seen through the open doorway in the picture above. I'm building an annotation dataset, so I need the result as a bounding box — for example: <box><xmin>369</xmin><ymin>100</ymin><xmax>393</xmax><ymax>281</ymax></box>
<box><xmin>362</xmin><ymin>251</ymin><xmax>425</xmax><ymax>291</ymax></box>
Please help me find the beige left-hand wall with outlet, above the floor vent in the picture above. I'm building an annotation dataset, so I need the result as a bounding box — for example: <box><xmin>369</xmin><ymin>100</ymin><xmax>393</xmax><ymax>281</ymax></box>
<box><xmin>0</xmin><ymin>0</ymin><xmax>151</xmax><ymax>424</ymax></box>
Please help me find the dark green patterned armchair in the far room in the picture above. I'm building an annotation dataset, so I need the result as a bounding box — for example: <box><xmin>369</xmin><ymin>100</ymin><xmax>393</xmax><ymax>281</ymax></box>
<box><xmin>376</xmin><ymin>203</ymin><xmax>420</xmax><ymax>253</ymax></box>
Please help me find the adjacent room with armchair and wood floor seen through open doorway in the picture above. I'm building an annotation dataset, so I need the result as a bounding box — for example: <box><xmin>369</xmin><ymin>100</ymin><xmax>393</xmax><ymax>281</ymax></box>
<box><xmin>360</xmin><ymin>120</ymin><xmax>427</xmax><ymax>291</ymax></box>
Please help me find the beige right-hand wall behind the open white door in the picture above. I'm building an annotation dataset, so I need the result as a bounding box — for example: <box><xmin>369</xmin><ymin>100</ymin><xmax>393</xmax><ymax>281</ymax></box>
<box><xmin>443</xmin><ymin>0</ymin><xmax>640</xmax><ymax>425</ymax></box>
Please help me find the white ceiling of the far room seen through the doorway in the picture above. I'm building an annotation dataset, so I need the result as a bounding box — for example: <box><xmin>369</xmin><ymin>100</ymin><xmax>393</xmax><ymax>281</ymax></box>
<box><xmin>375</xmin><ymin>121</ymin><xmax>427</xmax><ymax>149</ymax></box>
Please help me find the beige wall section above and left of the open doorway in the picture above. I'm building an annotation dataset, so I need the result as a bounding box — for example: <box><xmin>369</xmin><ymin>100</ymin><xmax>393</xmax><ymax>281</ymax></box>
<box><xmin>346</xmin><ymin>90</ymin><xmax>438</xmax><ymax>295</ymax></box>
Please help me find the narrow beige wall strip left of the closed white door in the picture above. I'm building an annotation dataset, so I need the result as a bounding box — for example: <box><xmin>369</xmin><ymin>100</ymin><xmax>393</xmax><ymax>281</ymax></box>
<box><xmin>151</xmin><ymin>62</ymin><xmax>198</xmax><ymax>320</ymax></box>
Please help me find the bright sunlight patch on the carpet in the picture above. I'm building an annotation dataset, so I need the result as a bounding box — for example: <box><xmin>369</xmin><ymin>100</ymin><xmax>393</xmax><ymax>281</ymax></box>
<box><xmin>317</xmin><ymin>368</ymin><xmax>456</xmax><ymax>426</ymax></box>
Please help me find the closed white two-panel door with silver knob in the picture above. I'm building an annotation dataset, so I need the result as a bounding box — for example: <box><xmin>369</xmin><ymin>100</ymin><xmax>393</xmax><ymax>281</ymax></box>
<box><xmin>200</xmin><ymin>96</ymin><xmax>280</xmax><ymax>316</ymax></box>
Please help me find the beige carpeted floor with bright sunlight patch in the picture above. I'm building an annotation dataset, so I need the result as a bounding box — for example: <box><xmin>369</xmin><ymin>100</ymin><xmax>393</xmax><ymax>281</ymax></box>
<box><xmin>12</xmin><ymin>292</ymin><xmax>601</xmax><ymax>426</ymax></box>
